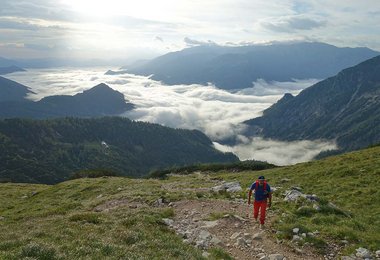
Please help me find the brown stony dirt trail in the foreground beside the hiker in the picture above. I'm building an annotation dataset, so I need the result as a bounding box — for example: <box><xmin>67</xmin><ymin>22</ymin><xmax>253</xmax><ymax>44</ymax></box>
<box><xmin>170</xmin><ymin>200</ymin><xmax>324</xmax><ymax>260</ymax></box>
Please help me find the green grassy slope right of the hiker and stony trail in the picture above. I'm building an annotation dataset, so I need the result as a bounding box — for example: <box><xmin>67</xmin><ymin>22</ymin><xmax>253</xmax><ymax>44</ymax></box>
<box><xmin>217</xmin><ymin>147</ymin><xmax>380</xmax><ymax>252</ymax></box>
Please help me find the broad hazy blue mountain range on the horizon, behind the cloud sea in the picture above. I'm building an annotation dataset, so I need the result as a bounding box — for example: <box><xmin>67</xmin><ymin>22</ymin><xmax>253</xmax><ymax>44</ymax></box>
<box><xmin>123</xmin><ymin>42</ymin><xmax>380</xmax><ymax>89</ymax></box>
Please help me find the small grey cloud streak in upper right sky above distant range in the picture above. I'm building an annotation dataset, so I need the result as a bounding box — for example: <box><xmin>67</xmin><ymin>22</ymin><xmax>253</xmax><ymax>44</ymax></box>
<box><xmin>260</xmin><ymin>16</ymin><xmax>327</xmax><ymax>33</ymax></box>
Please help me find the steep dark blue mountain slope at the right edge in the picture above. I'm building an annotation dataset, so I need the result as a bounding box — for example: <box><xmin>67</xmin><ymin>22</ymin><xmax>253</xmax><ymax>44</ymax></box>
<box><xmin>246</xmin><ymin>56</ymin><xmax>380</xmax><ymax>150</ymax></box>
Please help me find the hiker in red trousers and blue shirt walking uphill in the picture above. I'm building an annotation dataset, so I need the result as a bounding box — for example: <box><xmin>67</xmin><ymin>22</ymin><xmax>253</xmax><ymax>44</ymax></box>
<box><xmin>248</xmin><ymin>176</ymin><xmax>272</xmax><ymax>228</ymax></box>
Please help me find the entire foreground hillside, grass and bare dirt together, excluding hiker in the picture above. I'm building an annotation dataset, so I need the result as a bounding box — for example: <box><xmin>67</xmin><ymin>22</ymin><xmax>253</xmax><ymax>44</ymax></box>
<box><xmin>0</xmin><ymin>147</ymin><xmax>380</xmax><ymax>259</ymax></box>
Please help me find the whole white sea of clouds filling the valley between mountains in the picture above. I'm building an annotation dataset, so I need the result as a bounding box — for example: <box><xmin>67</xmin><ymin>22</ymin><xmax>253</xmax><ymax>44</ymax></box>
<box><xmin>7</xmin><ymin>68</ymin><xmax>336</xmax><ymax>165</ymax></box>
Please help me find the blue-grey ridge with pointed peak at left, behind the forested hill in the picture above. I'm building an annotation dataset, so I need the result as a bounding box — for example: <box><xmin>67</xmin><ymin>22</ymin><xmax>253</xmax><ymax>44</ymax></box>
<box><xmin>0</xmin><ymin>77</ymin><xmax>134</xmax><ymax>119</ymax></box>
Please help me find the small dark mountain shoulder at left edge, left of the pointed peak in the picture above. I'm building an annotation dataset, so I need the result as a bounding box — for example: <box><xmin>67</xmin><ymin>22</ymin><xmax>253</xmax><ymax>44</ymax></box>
<box><xmin>0</xmin><ymin>77</ymin><xmax>32</xmax><ymax>102</ymax></box>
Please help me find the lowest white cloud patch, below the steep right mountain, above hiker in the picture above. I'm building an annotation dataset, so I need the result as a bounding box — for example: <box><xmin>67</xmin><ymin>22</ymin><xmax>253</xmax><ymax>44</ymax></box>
<box><xmin>214</xmin><ymin>137</ymin><xmax>337</xmax><ymax>165</ymax></box>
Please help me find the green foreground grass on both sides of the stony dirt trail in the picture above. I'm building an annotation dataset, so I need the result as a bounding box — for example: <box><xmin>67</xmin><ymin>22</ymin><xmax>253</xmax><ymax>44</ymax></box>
<box><xmin>0</xmin><ymin>147</ymin><xmax>380</xmax><ymax>259</ymax></box>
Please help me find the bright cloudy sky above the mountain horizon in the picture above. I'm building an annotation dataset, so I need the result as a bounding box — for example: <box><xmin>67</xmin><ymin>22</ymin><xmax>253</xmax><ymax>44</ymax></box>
<box><xmin>0</xmin><ymin>0</ymin><xmax>380</xmax><ymax>62</ymax></box>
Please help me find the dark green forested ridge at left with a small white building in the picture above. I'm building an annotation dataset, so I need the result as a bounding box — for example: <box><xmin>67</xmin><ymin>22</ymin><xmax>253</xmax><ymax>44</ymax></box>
<box><xmin>0</xmin><ymin>117</ymin><xmax>238</xmax><ymax>183</ymax></box>
